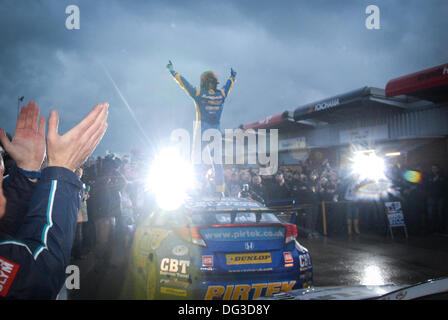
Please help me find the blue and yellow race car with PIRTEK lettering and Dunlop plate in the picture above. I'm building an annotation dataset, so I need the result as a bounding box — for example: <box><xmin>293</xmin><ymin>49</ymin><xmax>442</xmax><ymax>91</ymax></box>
<box><xmin>124</xmin><ymin>198</ymin><xmax>313</xmax><ymax>300</ymax></box>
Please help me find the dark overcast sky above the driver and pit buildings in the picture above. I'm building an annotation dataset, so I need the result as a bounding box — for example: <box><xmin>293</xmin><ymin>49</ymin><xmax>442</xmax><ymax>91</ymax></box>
<box><xmin>0</xmin><ymin>0</ymin><xmax>448</xmax><ymax>155</ymax></box>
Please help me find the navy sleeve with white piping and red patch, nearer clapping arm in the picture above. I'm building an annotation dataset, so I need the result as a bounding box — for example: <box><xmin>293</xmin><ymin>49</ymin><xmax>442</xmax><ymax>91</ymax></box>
<box><xmin>0</xmin><ymin>167</ymin><xmax>82</xmax><ymax>299</ymax></box>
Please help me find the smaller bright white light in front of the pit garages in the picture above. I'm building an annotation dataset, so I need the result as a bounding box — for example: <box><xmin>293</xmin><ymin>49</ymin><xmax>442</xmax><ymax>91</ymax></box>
<box><xmin>352</xmin><ymin>152</ymin><xmax>386</xmax><ymax>181</ymax></box>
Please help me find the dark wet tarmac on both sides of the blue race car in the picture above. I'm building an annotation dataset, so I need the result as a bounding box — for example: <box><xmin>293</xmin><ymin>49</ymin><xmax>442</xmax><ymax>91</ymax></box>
<box><xmin>68</xmin><ymin>234</ymin><xmax>448</xmax><ymax>299</ymax></box>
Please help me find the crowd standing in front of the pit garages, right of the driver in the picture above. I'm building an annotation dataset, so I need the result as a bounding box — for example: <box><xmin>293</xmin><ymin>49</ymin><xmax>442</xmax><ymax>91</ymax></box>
<box><xmin>225</xmin><ymin>160</ymin><xmax>448</xmax><ymax>237</ymax></box>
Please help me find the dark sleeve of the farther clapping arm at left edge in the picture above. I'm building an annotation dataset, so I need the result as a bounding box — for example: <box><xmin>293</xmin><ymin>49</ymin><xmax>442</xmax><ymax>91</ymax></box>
<box><xmin>0</xmin><ymin>166</ymin><xmax>36</xmax><ymax>236</ymax></box>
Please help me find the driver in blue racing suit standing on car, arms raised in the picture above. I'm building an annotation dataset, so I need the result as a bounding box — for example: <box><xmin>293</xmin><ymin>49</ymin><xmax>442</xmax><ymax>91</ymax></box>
<box><xmin>166</xmin><ymin>61</ymin><xmax>236</xmax><ymax>193</ymax></box>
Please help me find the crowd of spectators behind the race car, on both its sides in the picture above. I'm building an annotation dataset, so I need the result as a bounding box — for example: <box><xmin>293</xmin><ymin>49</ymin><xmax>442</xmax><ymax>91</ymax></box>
<box><xmin>62</xmin><ymin>149</ymin><xmax>448</xmax><ymax>261</ymax></box>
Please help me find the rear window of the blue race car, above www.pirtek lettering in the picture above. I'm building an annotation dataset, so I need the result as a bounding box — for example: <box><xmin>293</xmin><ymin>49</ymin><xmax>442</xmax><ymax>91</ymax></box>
<box><xmin>192</xmin><ymin>212</ymin><xmax>280</xmax><ymax>225</ymax></box>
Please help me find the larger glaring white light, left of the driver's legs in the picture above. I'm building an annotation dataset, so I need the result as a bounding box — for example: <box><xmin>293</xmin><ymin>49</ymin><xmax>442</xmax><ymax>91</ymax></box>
<box><xmin>147</xmin><ymin>148</ymin><xmax>194</xmax><ymax>211</ymax></box>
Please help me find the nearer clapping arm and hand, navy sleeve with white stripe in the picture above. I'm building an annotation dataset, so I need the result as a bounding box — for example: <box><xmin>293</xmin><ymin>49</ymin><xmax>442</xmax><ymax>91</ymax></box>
<box><xmin>0</xmin><ymin>103</ymin><xmax>108</xmax><ymax>299</ymax></box>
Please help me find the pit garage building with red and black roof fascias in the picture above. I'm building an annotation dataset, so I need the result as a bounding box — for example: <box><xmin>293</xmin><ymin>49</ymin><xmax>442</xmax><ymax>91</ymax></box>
<box><xmin>240</xmin><ymin>63</ymin><xmax>448</xmax><ymax>170</ymax></box>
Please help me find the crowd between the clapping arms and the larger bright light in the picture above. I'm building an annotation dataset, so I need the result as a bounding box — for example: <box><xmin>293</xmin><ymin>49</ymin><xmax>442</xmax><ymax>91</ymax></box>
<box><xmin>72</xmin><ymin>152</ymin><xmax>145</xmax><ymax>263</ymax></box>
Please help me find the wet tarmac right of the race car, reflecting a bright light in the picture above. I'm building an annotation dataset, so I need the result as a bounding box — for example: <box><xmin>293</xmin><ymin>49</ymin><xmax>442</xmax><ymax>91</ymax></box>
<box><xmin>299</xmin><ymin>234</ymin><xmax>448</xmax><ymax>286</ymax></box>
